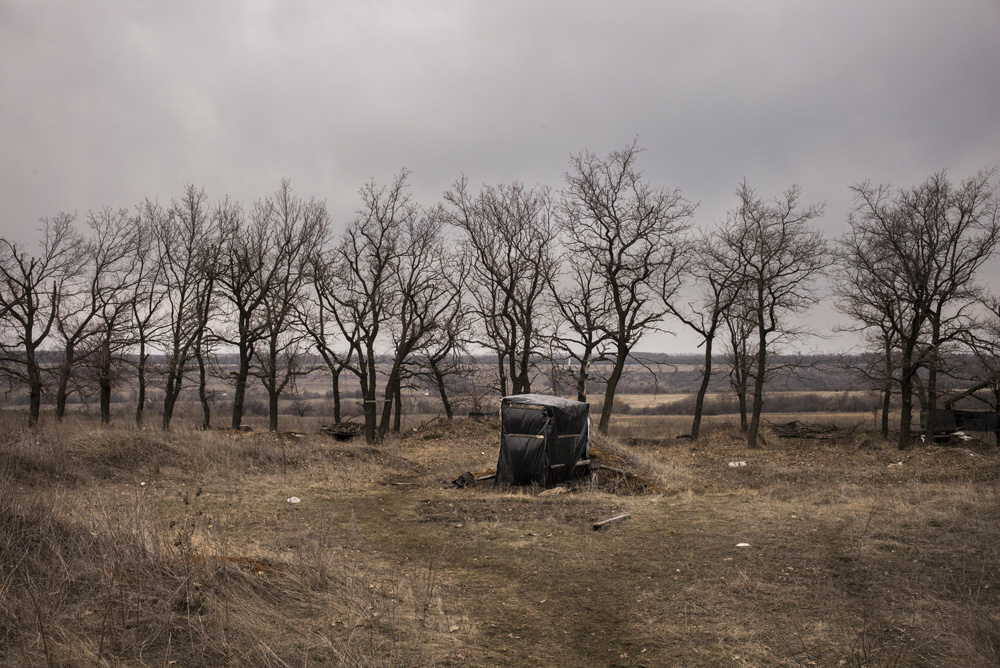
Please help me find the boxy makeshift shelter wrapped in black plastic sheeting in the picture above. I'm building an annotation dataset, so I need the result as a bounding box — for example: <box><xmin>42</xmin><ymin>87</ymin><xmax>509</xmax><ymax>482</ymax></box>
<box><xmin>497</xmin><ymin>394</ymin><xmax>590</xmax><ymax>487</ymax></box>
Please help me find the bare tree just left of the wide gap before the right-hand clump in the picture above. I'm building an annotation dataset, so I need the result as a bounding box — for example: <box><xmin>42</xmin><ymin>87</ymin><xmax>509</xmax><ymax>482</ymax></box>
<box><xmin>719</xmin><ymin>181</ymin><xmax>830</xmax><ymax>448</ymax></box>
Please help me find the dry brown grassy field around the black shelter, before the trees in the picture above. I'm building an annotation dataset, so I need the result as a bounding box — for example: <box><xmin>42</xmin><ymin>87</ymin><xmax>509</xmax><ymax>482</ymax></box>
<box><xmin>0</xmin><ymin>414</ymin><xmax>1000</xmax><ymax>667</ymax></box>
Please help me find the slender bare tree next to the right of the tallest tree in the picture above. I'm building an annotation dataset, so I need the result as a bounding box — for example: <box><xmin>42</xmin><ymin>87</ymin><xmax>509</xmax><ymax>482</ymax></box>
<box><xmin>666</xmin><ymin>228</ymin><xmax>746</xmax><ymax>439</ymax></box>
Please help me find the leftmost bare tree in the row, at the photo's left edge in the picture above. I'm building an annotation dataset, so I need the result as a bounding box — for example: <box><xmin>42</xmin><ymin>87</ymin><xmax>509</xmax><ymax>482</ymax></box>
<box><xmin>0</xmin><ymin>213</ymin><xmax>81</xmax><ymax>427</ymax></box>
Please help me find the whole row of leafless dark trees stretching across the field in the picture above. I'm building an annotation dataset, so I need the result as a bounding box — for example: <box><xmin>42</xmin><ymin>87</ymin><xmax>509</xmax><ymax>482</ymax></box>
<box><xmin>0</xmin><ymin>142</ymin><xmax>1000</xmax><ymax>447</ymax></box>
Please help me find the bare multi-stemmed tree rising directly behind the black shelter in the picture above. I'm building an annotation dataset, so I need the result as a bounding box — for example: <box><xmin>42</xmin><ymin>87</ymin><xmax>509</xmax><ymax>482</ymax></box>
<box><xmin>439</xmin><ymin>178</ymin><xmax>558</xmax><ymax>395</ymax></box>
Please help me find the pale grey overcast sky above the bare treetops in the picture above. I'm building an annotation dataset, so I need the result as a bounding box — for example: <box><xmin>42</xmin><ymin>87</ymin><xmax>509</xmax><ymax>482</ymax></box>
<box><xmin>0</xmin><ymin>0</ymin><xmax>1000</xmax><ymax>349</ymax></box>
